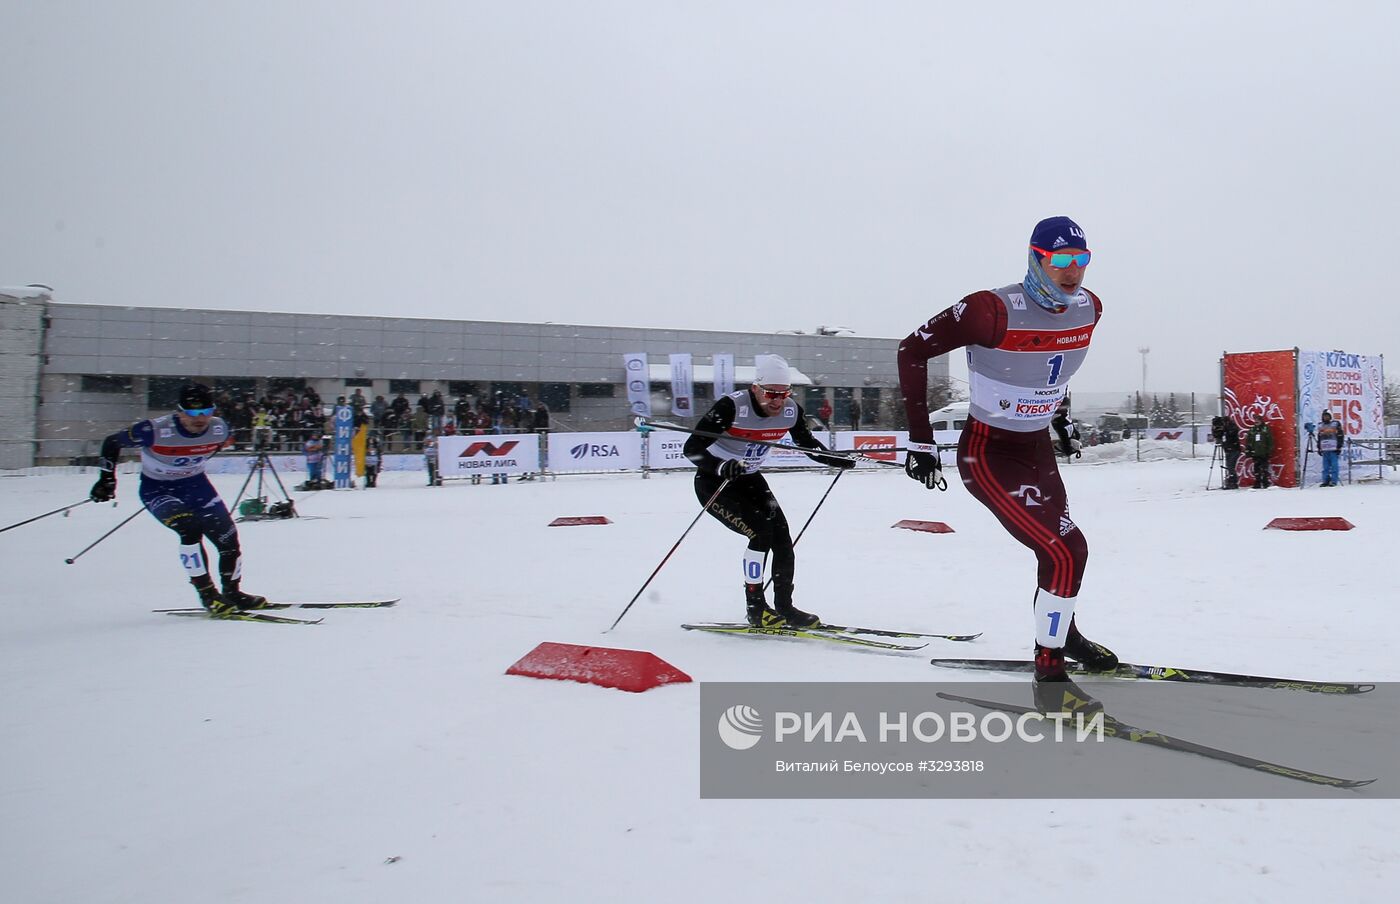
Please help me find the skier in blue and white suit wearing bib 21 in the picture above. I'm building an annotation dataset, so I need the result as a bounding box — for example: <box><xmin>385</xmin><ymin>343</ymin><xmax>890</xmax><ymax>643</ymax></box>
<box><xmin>91</xmin><ymin>383</ymin><xmax>267</xmax><ymax>619</ymax></box>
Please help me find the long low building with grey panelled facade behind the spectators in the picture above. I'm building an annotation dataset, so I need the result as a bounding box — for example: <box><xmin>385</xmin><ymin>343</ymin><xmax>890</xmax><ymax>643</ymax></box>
<box><xmin>0</xmin><ymin>288</ymin><xmax>948</xmax><ymax>469</ymax></box>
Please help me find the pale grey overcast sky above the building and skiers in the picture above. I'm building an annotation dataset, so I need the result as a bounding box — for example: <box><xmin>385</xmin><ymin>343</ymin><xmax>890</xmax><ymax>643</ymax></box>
<box><xmin>0</xmin><ymin>0</ymin><xmax>1400</xmax><ymax>390</ymax></box>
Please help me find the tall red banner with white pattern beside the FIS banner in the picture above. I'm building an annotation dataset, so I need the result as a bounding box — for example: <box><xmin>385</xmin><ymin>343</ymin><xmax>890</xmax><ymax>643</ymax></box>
<box><xmin>1221</xmin><ymin>348</ymin><xmax>1298</xmax><ymax>487</ymax></box>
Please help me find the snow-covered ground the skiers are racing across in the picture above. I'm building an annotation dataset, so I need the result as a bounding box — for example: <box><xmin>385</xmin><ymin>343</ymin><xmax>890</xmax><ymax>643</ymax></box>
<box><xmin>0</xmin><ymin>461</ymin><xmax>1400</xmax><ymax>904</ymax></box>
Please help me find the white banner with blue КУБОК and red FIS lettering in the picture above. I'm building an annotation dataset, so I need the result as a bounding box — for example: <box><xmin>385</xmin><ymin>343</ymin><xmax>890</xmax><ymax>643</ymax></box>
<box><xmin>1298</xmin><ymin>351</ymin><xmax>1386</xmax><ymax>438</ymax></box>
